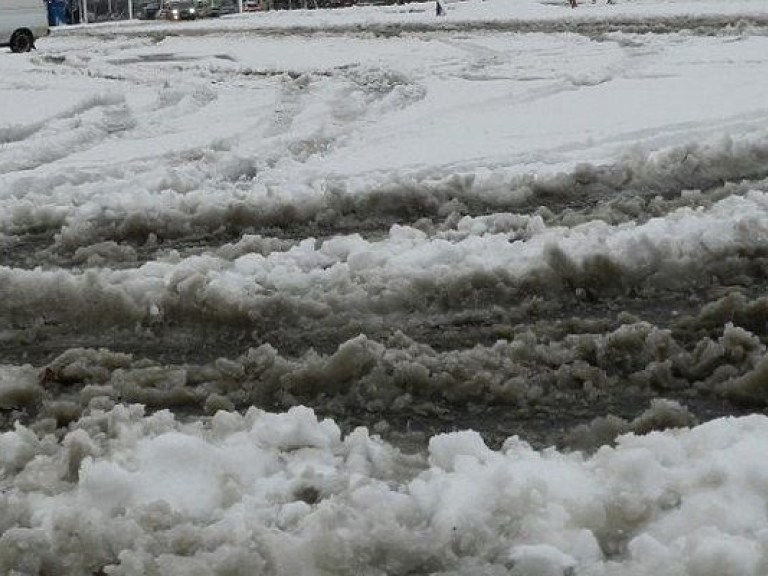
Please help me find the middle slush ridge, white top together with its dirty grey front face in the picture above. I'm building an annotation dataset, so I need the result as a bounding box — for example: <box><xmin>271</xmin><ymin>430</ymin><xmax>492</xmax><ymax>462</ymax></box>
<box><xmin>0</xmin><ymin>193</ymin><xmax>768</xmax><ymax>356</ymax></box>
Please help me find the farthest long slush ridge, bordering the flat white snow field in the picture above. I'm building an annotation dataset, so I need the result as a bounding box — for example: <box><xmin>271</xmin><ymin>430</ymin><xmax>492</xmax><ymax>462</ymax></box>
<box><xmin>6</xmin><ymin>133</ymin><xmax>768</xmax><ymax>254</ymax></box>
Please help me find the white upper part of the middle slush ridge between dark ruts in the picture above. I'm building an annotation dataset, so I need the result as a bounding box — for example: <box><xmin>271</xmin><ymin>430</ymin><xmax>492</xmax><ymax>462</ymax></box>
<box><xmin>0</xmin><ymin>192</ymin><xmax>768</xmax><ymax>324</ymax></box>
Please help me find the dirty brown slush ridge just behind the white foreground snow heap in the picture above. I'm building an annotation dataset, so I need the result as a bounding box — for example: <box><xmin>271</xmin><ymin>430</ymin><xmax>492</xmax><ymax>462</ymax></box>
<box><xmin>0</xmin><ymin>312</ymin><xmax>768</xmax><ymax>438</ymax></box>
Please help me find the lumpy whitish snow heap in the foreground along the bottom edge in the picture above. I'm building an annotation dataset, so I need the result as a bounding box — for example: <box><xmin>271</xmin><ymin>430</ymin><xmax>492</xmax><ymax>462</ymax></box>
<box><xmin>0</xmin><ymin>405</ymin><xmax>768</xmax><ymax>576</ymax></box>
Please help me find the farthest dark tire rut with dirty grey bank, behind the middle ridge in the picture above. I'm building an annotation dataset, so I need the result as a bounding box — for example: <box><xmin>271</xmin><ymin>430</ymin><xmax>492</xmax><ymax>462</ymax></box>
<box><xmin>3</xmin><ymin>134</ymin><xmax>768</xmax><ymax>267</ymax></box>
